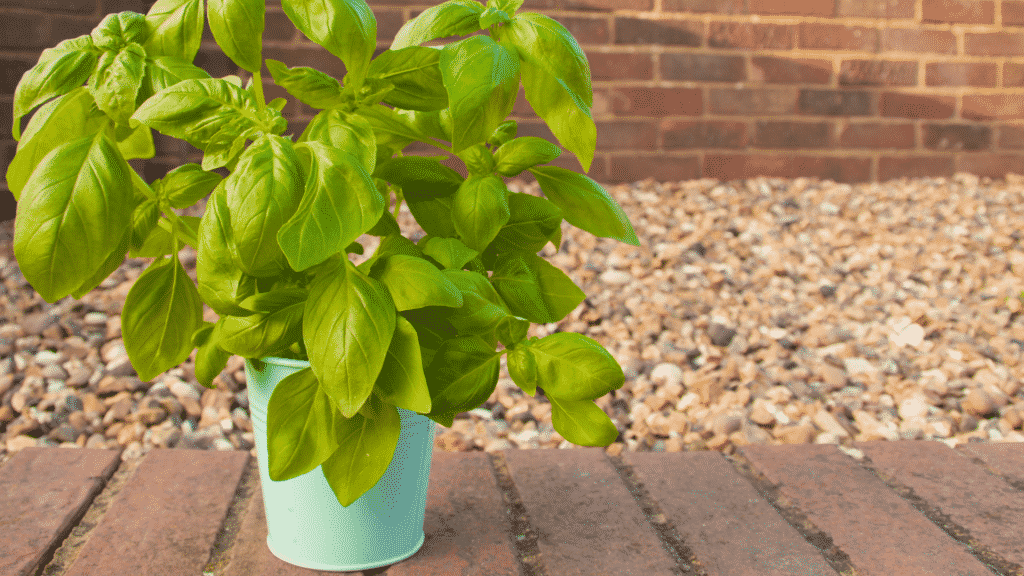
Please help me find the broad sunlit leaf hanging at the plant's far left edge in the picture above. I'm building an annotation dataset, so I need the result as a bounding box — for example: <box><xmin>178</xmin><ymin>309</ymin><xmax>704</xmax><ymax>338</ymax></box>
<box><xmin>13</xmin><ymin>132</ymin><xmax>134</xmax><ymax>302</ymax></box>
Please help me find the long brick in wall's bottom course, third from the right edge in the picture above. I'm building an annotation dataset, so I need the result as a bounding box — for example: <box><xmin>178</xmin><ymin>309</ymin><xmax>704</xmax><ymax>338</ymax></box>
<box><xmin>702</xmin><ymin>154</ymin><xmax>871</xmax><ymax>182</ymax></box>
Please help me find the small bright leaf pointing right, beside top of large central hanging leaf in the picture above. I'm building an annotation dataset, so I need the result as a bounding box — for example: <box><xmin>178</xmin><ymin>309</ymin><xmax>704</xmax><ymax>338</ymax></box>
<box><xmin>379</xmin><ymin>254</ymin><xmax>462</xmax><ymax>312</ymax></box>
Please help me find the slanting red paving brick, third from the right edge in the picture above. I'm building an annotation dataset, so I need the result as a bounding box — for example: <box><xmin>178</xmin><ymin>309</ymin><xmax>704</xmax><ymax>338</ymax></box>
<box><xmin>739</xmin><ymin>445</ymin><xmax>990</xmax><ymax>576</ymax></box>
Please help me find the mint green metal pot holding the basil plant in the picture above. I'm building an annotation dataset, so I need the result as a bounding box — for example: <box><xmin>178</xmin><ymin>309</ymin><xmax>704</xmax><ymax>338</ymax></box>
<box><xmin>246</xmin><ymin>358</ymin><xmax>436</xmax><ymax>571</ymax></box>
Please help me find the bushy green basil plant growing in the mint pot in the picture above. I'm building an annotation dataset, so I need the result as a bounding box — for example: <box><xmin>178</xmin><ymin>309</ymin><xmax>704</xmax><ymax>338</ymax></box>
<box><xmin>7</xmin><ymin>0</ymin><xmax>639</xmax><ymax>506</ymax></box>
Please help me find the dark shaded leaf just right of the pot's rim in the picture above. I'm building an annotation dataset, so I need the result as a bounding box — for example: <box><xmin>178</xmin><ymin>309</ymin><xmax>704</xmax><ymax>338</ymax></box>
<box><xmin>426</xmin><ymin>336</ymin><xmax>502</xmax><ymax>427</ymax></box>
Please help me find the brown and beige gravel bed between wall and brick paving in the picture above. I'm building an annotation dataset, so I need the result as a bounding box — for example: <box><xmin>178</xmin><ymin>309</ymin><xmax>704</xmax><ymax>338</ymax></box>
<box><xmin>0</xmin><ymin>173</ymin><xmax>1024</xmax><ymax>463</ymax></box>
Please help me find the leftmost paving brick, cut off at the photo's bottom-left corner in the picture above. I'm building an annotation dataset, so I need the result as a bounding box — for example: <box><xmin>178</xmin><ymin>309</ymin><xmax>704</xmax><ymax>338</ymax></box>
<box><xmin>0</xmin><ymin>448</ymin><xmax>121</xmax><ymax>576</ymax></box>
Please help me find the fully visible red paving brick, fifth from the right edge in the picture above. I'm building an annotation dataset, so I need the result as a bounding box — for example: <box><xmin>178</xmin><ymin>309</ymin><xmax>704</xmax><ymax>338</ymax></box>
<box><xmin>503</xmin><ymin>448</ymin><xmax>676</xmax><ymax>576</ymax></box>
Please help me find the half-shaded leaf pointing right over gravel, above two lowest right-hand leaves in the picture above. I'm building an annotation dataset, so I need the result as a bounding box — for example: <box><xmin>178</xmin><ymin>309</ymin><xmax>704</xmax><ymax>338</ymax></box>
<box><xmin>490</xmin><ymin>252</ymin><xmax>587</xmax><ymax>324</ymax></box>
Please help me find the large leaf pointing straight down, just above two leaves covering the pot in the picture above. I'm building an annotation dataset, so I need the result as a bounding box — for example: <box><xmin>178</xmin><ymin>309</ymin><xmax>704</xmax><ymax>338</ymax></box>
<box><xmin>302</xmin><ymin>259</ymin><xmax>397</xmax><ymax>418</ymax></box>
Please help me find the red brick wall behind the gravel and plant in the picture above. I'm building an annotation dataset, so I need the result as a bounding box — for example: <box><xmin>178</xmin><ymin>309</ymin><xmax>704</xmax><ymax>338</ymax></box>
<box><xmin>0</xmin><ymin>0</ymin><xmax>1024</xmax><ymax>219</ymax></box>
